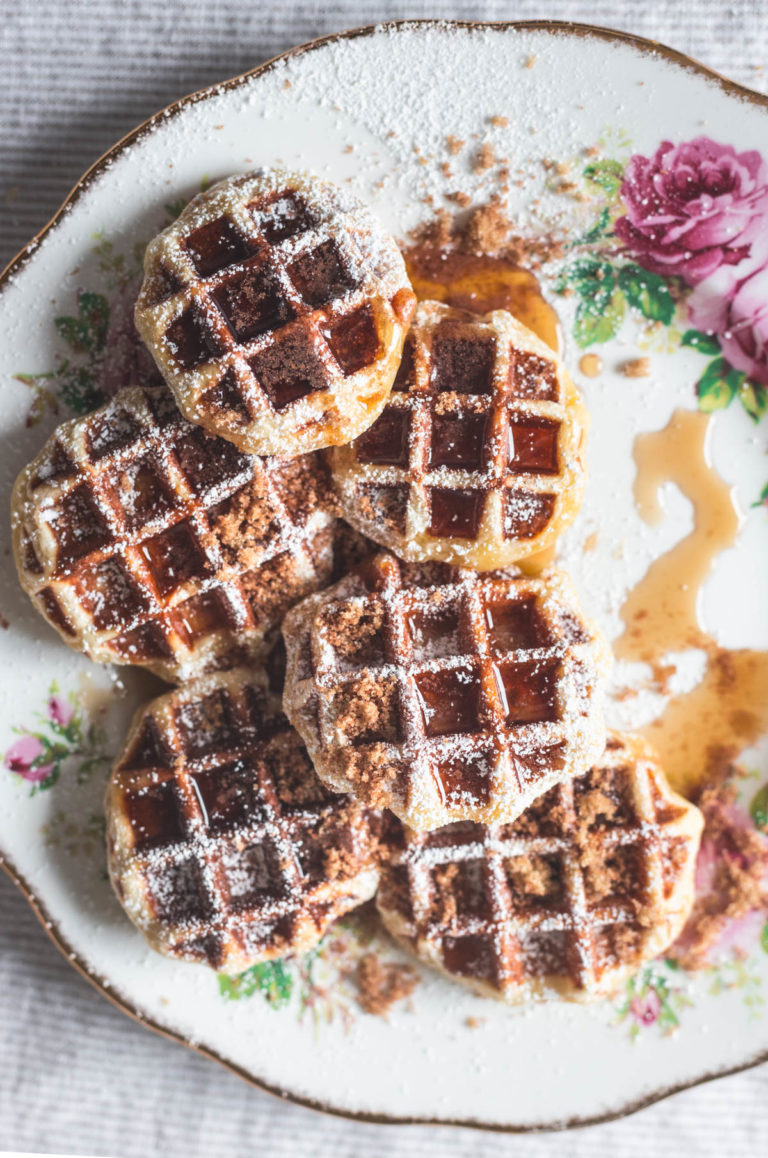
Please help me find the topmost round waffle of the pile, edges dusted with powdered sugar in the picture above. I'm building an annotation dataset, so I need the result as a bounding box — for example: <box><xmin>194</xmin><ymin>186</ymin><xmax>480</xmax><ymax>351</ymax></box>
<box><xmin>136</xmin><ymin>170</ymin><xmax>415</xmax><ymax>455</ymax></box>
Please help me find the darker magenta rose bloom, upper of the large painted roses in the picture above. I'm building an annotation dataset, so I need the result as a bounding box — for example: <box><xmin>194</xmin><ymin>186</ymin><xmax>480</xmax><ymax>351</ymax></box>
<box><xmin>615</xmin><ymin>137</ymin><xmax>768</xmax><ymax>286</ymax></box>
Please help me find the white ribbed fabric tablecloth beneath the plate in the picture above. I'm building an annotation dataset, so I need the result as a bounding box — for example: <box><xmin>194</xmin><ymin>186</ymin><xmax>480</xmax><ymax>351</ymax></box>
<box><xmin>0</xmin><ymin>0</ymin><xmax>768</xmax><ymax>1158</ymax></box>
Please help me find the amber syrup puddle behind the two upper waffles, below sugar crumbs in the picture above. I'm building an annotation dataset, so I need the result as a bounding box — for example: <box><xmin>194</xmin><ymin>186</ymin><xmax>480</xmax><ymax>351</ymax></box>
<box><xmin>403</xmin><ymin>244</ymin><xmax>561</xmax><ymax>352</ymax></box>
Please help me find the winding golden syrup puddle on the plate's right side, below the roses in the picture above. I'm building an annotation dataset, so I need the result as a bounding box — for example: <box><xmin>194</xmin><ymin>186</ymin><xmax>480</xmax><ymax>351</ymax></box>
<box><xmin>614</xmin><ymin>410</ymin><xmax>768</xmax><ymax>793</ymax></box>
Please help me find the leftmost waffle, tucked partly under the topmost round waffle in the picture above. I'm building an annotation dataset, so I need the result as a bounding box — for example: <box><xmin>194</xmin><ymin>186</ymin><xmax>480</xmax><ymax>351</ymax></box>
<box><xmin>13</xmin><ymin>387</ymin><xmax>335</xmax><ymax>681</ymax></box>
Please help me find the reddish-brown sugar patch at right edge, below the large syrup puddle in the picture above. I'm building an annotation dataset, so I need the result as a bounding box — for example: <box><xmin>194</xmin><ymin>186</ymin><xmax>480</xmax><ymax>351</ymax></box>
<box><xmin>672</xmin><ymin>753</ymin><xmax>768</xmax><ymax>969</ymax></box>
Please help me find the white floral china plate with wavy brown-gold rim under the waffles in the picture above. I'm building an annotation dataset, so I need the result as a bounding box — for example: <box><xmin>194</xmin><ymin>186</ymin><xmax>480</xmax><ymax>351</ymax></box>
<box><xmin>0</xmin><ymin>22</ymin><xmax>768</xmax><ymax>1129</ymax></box>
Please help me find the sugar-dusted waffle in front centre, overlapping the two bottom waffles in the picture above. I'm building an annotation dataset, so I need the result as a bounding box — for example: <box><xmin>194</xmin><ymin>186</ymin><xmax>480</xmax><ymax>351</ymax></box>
<box><xmin>283</xmin><ymin>554</ymin><xmax>609</xmax><ymax>829</ymax></box>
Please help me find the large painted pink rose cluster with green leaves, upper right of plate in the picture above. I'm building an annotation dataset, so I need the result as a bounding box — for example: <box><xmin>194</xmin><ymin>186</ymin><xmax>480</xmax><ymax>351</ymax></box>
<box><xmin>558</xmin><ymin>137</ymin><xmax>768</xmax><ymax>422</ymax></box>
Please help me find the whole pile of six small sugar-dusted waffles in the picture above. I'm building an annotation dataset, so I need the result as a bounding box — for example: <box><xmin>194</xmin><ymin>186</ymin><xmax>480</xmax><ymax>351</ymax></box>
<box><xmin>14</xmin><ymin>170</ymin><xmax>701</xmax><ymax>1002</ymax></box>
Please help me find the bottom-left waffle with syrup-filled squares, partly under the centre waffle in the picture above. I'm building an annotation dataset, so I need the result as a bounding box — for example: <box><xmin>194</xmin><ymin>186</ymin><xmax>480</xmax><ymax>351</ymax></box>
<box><xmin>107</xmin><ymin>668</ymin><xmax>379</xmax><ymax>974</ymax></box>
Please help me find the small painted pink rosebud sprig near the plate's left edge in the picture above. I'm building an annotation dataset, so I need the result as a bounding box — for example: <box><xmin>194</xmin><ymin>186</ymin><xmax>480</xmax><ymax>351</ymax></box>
<box><xmin>3</xmin><ymin>683</ymin><xmax>110</xmax><ymax>796</ymax></box>
